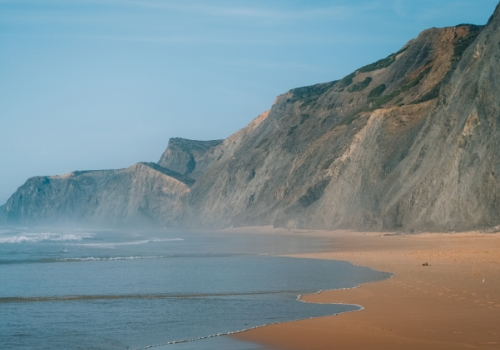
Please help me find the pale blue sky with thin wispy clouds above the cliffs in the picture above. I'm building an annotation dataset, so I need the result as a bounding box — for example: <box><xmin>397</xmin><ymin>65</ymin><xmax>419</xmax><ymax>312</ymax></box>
<box><xmin>0</xmin><ymin>0</ymin><xmax>498</xmax><ymax>204</ymax></box>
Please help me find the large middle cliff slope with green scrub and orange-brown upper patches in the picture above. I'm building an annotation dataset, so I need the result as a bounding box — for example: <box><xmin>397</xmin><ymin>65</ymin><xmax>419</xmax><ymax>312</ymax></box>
<box><xmin>181</xmin><ymin>21</ymin><xmax>488</xmax><ymax>229</ymax></box>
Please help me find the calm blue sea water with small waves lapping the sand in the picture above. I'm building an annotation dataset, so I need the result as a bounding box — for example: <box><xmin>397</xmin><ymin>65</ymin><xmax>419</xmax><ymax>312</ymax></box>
<box><xmin>0</xmin><ymin>228</ymin><xmax>389</xmax><ymax>350</ymax></box>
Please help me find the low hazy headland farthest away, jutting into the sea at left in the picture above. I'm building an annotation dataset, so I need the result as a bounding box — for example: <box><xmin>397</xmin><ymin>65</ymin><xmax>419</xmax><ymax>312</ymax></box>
<box><xmin>0</xmin><ymin>163</ymin><xmax>194</xmax><ymax>226</ymax></box>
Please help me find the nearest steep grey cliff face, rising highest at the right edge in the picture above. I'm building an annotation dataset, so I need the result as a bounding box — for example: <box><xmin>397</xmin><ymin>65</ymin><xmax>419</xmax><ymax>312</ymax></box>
<box><xmin>382</xmin><ymin>7</ymin><xmax>500</xmax><ymax>230</ymax></box>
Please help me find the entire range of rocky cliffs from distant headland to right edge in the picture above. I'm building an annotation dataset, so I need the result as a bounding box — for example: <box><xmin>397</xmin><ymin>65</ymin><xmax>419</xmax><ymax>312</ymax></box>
<box><xmin>0</xmin><ymin>4</ymin><xmax>500</xmax><ymax>231</ymax></box>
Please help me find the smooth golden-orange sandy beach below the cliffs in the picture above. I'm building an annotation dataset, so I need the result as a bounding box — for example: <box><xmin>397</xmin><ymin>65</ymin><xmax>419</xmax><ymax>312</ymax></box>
<box><xmin>235</xmin><ymin>229</ymin><xmax>500</xmax><ymax>350</ymax></box>
